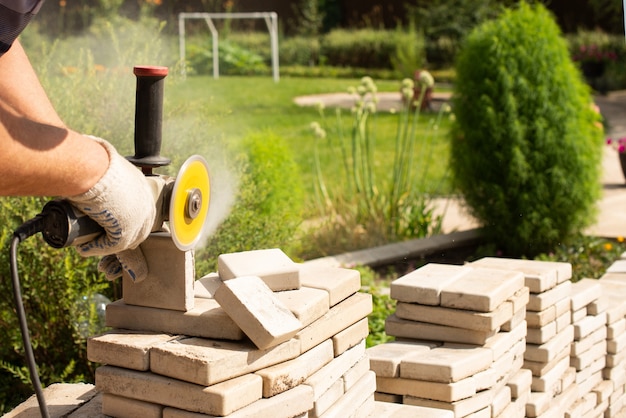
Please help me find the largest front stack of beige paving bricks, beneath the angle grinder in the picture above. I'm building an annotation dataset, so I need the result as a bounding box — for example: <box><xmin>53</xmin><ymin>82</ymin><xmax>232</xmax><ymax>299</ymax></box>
<box><xmin>88</xmin><ymin>249</ymin><xmax>376</xmax><ymax>418</ymax></box>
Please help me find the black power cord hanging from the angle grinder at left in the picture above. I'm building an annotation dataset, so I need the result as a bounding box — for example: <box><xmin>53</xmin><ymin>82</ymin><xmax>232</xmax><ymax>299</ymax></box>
<box><xmin>10</xmin><ymin>214</ymin><xmax>50</xmax><ymax>418</ymax></box>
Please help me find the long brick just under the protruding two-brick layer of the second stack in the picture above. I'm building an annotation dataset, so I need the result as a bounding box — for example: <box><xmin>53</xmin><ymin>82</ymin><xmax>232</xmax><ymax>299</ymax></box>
<box><xmin>376</xmin><ymin>376</ymin><xmax>476</xmax><ymax>402</ymax></box>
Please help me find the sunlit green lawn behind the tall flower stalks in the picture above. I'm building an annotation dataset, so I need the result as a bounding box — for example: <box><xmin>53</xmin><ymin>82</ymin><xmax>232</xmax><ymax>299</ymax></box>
<box><xmin>163</xmin><ymin>77</ymin><xmax>449</xmax><ymax>212</ymax></box>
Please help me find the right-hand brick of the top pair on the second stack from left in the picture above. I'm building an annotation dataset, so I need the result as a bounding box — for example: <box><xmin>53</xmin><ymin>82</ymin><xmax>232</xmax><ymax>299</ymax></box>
<box><xmin>441</xmin><ymin>268</ymin><xmax>524</xmax><ymax>312</ymax></box>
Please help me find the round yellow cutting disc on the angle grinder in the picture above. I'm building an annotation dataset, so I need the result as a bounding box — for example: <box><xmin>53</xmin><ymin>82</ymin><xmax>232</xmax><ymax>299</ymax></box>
<box><xmin>169</xmin><ymin>155</ymin><xmax>211</xmax><ymax>251</ymax></box>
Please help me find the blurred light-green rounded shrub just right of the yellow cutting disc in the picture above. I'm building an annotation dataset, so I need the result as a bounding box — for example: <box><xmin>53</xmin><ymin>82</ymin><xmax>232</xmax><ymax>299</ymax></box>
<box><xmin>196</xmin><ymin>131</ymin><xmax>303</xmax><ymax>273</ymax></box>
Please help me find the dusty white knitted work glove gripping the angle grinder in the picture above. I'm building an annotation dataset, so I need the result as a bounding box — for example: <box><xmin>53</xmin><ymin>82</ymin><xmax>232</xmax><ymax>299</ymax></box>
<box><xmin>67</xmin><ymin>137</ymin><xmax>156</xmax><ymax>282</ymax></box>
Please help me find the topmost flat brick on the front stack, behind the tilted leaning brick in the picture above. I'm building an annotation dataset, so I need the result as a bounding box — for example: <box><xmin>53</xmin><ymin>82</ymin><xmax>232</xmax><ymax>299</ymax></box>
<box><xmin>217</xmin><ymin>248</ymin><xmax>300</xmax><ymax>291</ymax></box>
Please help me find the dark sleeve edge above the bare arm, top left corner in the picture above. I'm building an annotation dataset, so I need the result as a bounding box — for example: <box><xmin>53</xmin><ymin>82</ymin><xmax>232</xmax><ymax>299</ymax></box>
<box><xmin>0</xmin><ymin>0</ymin><xmax>44</xmax><ymax>56</ymax></box>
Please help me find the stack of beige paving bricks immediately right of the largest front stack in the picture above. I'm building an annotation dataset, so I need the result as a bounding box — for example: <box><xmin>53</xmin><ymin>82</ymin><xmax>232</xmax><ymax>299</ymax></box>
<box><xmin>368</xmin><ymin>264</ymin><xmax>531</xmax><ymax>417</ymax></box>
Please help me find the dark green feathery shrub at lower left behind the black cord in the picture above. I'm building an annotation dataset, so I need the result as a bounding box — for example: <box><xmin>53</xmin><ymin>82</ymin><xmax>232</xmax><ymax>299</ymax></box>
<box><xmin>0</xmin><ymin>198</ymin><xmax>106</xmax><ymax>415</ymax></box>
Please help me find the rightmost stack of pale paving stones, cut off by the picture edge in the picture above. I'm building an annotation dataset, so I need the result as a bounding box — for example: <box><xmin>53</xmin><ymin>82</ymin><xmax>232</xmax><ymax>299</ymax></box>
<box><xmin>598</xmin><ymin>260</ymin><xmax>626</xmax><ymax>417</ymax></box>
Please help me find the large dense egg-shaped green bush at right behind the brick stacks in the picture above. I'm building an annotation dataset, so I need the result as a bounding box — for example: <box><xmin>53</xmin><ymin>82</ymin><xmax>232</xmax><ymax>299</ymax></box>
<box><xmin>450</xmin><ymin>3</ymin><xmax>603</xmax><ymax>256</ymax></box>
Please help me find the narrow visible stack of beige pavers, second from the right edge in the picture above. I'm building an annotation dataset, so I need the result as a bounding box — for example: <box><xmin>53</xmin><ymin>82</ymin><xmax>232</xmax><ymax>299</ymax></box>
<box><xmin>567</xmin><ymin>279</ymin><xmax>613</xmax><ymax>417</ymax></box>
